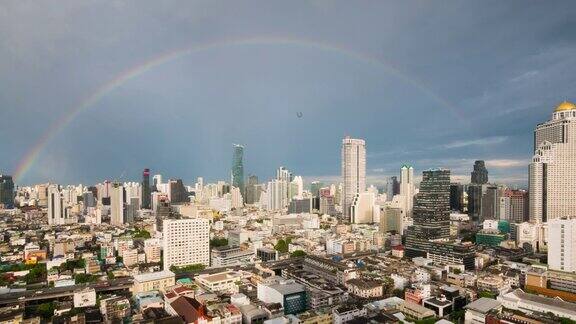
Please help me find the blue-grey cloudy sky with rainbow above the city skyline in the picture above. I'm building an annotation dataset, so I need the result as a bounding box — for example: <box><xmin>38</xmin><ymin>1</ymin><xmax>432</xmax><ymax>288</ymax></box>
<box><xmin>0</xmin><ymin>0</ymin><xmax>576</xmax><ymax>187</ymax></box>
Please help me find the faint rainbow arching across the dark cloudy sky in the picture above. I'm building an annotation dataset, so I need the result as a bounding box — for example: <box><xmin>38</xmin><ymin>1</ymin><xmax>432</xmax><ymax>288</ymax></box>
<box><xmin>14</xmin><ymin>37</ymin><xmax>459</xmax><ymax>180</ymax></box>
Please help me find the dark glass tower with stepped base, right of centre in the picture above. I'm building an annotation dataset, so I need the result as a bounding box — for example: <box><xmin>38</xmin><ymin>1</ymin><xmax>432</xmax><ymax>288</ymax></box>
<box><xmin>405</xmin><ymin>169</ymin><xmax>450</xmax><ymax>258</ymax></box>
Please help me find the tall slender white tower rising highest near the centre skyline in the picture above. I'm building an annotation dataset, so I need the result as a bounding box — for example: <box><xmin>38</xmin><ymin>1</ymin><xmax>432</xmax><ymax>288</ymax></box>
<box><xmin>342</xmin><ymin>136</ymin><xmax>366</xmax><ymax>220</ymax></box>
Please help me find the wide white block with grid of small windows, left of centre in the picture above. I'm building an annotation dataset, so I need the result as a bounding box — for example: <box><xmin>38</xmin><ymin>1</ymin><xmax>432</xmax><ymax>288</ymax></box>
<box><xmin>162</xmin><ymin>218</ymin><xmax>210</xmax><ymax>270</ymax></box>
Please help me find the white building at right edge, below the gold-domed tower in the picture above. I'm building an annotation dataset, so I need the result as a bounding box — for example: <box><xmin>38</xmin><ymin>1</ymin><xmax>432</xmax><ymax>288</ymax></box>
<box><xmin>548</xmin><ymin>217</ymin><xmax>576</xmax><ymax>272</ymax></box>
